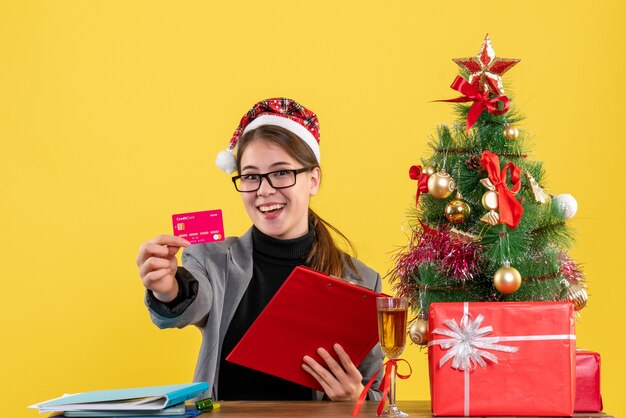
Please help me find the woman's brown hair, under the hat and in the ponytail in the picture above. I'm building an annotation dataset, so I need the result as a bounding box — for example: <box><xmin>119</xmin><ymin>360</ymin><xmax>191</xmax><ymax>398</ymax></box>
<box><xmin>237</xmin><ymin>125</ymin><xmax>363</xmax><ymax>280</ymax></box>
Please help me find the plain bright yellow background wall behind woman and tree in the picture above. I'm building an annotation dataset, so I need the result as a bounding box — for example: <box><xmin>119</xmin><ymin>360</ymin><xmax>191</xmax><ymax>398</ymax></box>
<box><xmin>0</xmin><ymin>0</ymin><xmax>626</xmax><ymax>417</ymax></box>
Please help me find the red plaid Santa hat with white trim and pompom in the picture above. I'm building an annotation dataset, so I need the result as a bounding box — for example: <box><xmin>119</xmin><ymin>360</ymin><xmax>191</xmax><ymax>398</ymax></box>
<box><xmin>215</xmin><ymin>97</ymin><xmax>320</xmax><ymax>174</ymax></box>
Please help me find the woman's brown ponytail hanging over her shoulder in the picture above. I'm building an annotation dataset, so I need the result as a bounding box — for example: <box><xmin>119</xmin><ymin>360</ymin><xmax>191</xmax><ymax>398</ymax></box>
<box><xmin>307</xmin><ymin>208</ymin><xmax>363</xmax><ymax>280</ymax></box>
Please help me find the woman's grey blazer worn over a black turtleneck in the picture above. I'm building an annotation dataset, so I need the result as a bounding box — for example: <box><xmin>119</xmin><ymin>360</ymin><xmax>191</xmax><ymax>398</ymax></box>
<box><xmin>145</xmin><ymin>229</ymin><xmax>383</xmax><ymax>400</ymax></box>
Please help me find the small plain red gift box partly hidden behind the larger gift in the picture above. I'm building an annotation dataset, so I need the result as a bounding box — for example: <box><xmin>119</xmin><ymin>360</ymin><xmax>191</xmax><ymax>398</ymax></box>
<box><xmin>574</xmin><ymin>349</ymin><xmax>602</xmax><ymax>412</ymax></box>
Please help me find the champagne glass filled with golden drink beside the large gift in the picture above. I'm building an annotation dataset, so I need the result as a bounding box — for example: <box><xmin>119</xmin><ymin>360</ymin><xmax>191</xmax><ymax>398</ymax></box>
<box><xmin>376</xmin><ymin>297</ymin><xmax>408</xmax><ymax>417</ymax></box>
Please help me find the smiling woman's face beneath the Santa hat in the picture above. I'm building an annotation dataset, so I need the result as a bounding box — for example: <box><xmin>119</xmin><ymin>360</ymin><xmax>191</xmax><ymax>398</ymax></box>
<box><xmin>239</xmin><ymin>139</ymin><xmax>320</xmax><ymax>239</ymax></box>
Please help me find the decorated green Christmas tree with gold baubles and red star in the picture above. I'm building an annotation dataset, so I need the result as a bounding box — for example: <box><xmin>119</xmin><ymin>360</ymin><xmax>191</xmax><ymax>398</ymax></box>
<box><xmin>391</xmin><ymin>35</ymin><xmax>587</xmax><ymax>344</ymax></box>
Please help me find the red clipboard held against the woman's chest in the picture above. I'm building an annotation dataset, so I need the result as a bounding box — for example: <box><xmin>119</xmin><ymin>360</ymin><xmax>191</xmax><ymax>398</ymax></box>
<box><xmin>226</xmin><ymin>266</ymin><xmax>382</xmax><ymax>391</ymax></box>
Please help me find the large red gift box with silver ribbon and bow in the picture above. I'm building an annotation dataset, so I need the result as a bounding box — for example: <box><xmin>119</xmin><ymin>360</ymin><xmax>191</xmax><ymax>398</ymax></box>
<box><xmin>428</xmin><ymin>302</ymin><xmax>576</xmax><ymax>416</ymax></box>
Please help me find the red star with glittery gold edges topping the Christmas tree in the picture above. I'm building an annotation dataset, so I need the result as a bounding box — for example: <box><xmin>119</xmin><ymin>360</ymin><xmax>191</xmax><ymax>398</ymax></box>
<box><xmin>452</xmin><ymin>34</ymin><xmax>520</xmax><ymax>96</ymax></box>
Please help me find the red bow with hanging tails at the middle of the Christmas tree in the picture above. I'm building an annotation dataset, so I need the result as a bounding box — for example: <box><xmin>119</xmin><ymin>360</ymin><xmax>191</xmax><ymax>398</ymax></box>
<box><xmin>480</xmin><ymin>151</ymin><xmax>524</xmax><ymax>229</ymax></box>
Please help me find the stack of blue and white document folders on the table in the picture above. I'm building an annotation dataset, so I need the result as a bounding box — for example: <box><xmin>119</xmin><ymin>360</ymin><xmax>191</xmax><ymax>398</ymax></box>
<box><xmin>29</xmin><ymin>382</ymin><xmax>209</xmax><ymax>418</ymax></box>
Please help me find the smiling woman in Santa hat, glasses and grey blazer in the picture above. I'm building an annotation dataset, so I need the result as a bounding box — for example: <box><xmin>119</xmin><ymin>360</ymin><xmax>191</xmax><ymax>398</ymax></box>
<box><xmin>137</xmin><ymin>98</ymin><xmax>383</xmax><ymax>400</ymax></box>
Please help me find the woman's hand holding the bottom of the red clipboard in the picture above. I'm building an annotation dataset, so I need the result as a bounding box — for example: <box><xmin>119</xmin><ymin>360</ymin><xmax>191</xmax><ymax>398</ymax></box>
<box><xmin>302</xmin><ymin>344</ymin><xmax>363</xmax><ymax>401</ymax></box>
